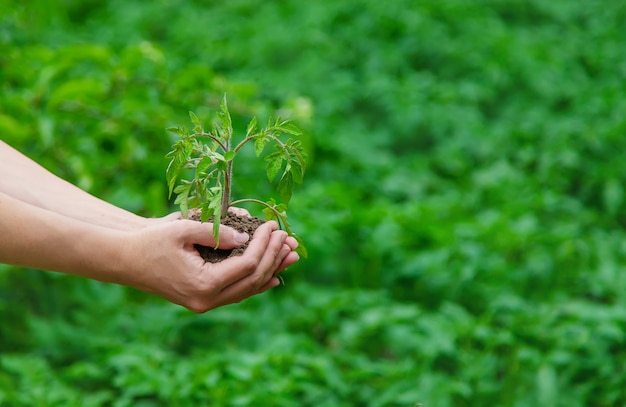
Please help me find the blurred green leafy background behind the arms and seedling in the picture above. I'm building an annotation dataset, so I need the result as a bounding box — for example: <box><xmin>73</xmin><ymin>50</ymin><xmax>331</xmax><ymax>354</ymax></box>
<box><xmin>0</xmin><ymin>0</ymin><xmax>626</xmax><ymax>407</ymax></box>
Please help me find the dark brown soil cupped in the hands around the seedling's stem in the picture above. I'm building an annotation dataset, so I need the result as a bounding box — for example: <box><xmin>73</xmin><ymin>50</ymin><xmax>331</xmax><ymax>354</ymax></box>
<box><xmin>187</xmin><ymin>209</ymin><xmax>265</xmax><ymax>263</ymax></box>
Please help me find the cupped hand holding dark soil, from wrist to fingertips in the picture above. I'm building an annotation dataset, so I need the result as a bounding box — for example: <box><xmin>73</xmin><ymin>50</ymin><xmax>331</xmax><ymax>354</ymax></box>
<box><xmin>117</xmin><ymin>220</ymin><xmax>299</xmax><ymax>313</ymax></box>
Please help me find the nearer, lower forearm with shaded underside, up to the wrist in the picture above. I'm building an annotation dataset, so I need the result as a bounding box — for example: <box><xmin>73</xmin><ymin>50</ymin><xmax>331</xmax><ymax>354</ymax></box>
<box><xmin>0</xmin><ymin>192</ymin><xmax>126</xmax><ymax>282</ymax></box>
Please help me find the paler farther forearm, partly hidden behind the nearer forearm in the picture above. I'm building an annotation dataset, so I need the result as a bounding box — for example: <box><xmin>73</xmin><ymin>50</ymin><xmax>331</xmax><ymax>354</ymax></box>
<box><xmin>0</xmin><ymin>141</ymin><xmax>148</xmax><ymax>230</ymax></box>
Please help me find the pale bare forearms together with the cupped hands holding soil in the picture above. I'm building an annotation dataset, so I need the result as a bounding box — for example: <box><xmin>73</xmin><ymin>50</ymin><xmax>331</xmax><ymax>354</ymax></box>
<box><xmin>0</xmin><ymin>141</ymin><xmax>299</xmax><ymax>313</ymax></box>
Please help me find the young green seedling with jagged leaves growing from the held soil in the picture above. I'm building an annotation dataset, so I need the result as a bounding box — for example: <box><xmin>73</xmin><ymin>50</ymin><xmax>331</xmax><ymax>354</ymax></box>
<box><xmin>166</xmin><ymin>97</ymin><xmax>306</xmax><ymax>257</ymax></box>
